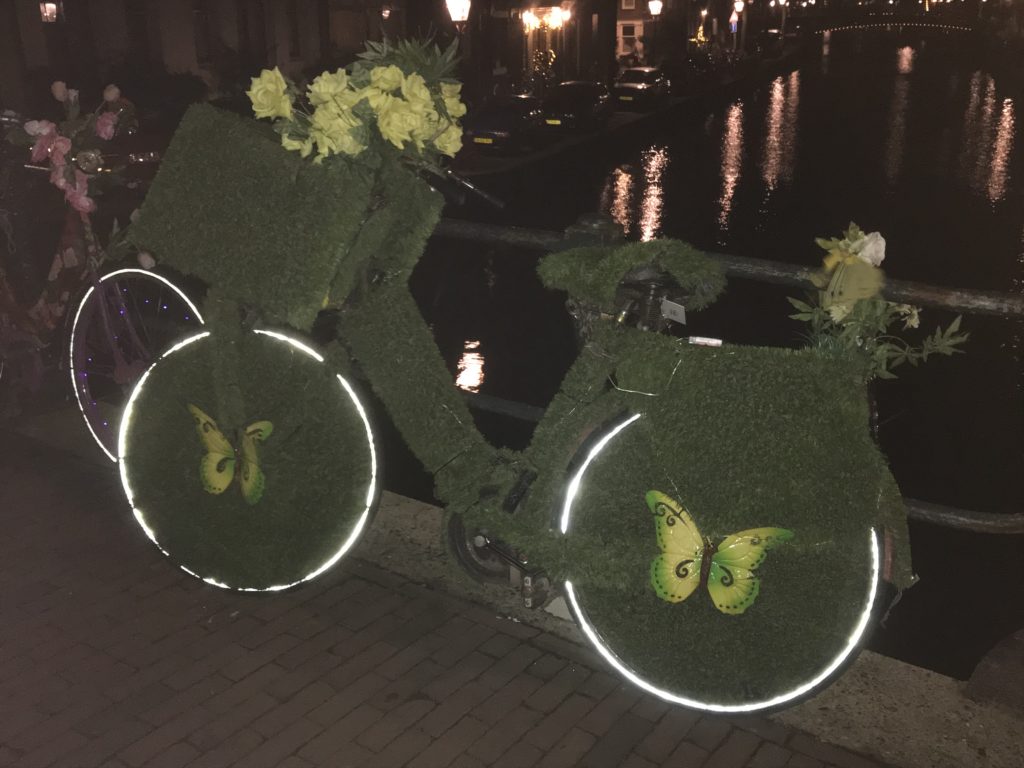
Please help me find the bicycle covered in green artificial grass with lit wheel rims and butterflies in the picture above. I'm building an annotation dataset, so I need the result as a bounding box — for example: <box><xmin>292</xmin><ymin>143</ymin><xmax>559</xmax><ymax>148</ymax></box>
<box><xmin>119</xmin><ymin>97</ymin><xmax>908</xmax><ymax>712</ymax></box>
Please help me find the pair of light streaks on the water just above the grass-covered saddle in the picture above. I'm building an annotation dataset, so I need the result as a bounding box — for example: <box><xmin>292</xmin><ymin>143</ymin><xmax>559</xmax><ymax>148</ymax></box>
<box><xmin>601</xmin><ymin>146</ymin><xmax>669</xmax><ymax>241</ymax></box>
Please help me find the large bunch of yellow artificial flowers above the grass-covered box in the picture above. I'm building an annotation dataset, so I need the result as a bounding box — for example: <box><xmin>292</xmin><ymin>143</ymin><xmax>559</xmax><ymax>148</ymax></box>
<box><xmin>246</xmin><ymin>40</ymin><xmax>466</xmax><ymax>168</ymax></box>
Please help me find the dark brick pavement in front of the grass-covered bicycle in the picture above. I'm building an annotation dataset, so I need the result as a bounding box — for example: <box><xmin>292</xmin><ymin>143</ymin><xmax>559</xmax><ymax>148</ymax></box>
<box><xmin>0</xmin><ymin>436</ymin><xmax>897</xmax><ymax>768</ymax></box>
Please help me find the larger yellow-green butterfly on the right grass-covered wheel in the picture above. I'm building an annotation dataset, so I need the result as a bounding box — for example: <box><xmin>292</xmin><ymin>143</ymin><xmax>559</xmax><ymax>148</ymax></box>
<box><xmin>646</xmin><ymin>490</ymin><xmax>794</xmax><ymax>615</ymax></box>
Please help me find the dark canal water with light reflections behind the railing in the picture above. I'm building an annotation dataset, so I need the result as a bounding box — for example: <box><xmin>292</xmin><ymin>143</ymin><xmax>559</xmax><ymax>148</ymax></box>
<box><xmin>414</xmin><ymin>30</ymin><xmax>1024</xmax><ymax>678</ymax></box>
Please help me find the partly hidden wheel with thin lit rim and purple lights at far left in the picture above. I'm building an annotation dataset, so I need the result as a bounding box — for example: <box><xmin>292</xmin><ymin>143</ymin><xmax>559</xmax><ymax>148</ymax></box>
<box><xmin>68</xmin><ymin>268</ymin><xmax>203</xmax><ymax>462</ymax></box>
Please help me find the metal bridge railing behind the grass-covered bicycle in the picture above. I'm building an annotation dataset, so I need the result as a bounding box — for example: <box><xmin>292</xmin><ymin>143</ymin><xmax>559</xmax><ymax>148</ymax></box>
<box><xmin>434</xmin><ymin>215</ymin><xmax>1024</xmax><ymax>535</ymax></box>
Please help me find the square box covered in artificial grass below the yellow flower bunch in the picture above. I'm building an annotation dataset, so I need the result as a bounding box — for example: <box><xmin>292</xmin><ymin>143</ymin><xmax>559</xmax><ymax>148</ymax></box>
<box><xmin>130</xmin><ymin>104</ymin><xmax>378</xmax><ymax>330</ymax></box>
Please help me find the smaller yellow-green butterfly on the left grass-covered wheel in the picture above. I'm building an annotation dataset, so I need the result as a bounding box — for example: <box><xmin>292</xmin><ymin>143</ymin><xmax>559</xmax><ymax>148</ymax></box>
<box><xmin>188</xmin><ymin>402</ymin><xmax>273</xmax><ymax>505</ymax></box>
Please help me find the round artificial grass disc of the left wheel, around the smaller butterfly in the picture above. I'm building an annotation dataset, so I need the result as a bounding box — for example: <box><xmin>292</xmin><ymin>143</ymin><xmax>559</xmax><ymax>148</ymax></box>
<box><xmin>119</xmin><ymin>334</ymin><xmax>379</xmax><ymax>589</ymax></box>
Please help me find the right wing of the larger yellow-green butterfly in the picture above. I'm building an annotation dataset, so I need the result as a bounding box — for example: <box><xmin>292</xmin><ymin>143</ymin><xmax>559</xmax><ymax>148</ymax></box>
<box><xmin>708</xmin><ymin>528</ymin><xmax>793</xmax><ymax>615</ymax></box>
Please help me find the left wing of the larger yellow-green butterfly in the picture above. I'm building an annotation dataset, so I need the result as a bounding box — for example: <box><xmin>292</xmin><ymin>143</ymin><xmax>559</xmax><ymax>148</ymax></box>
<box><xmin>646</xmin><ymin>490</ymin><xmax>703</xmax><ymax>603</ymax></box>
